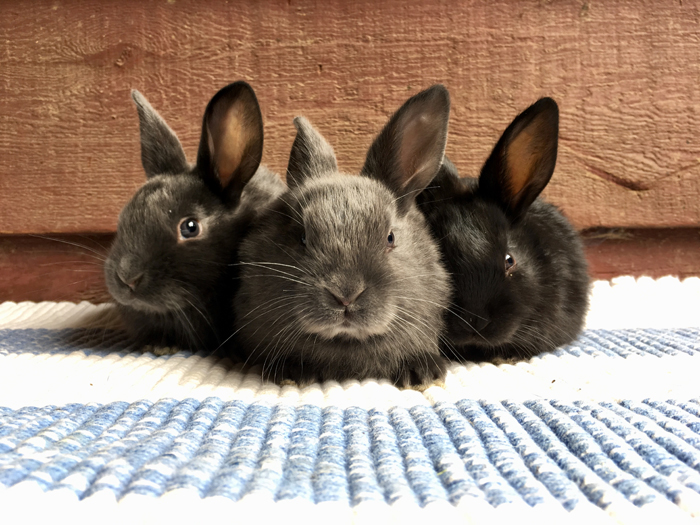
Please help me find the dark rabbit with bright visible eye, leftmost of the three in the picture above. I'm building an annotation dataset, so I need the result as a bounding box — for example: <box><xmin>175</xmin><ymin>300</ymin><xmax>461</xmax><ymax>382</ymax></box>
<box><xmin>105</xmin><ymin>82</ymin><xmax>285</xmax><ymax>350</ymax></box>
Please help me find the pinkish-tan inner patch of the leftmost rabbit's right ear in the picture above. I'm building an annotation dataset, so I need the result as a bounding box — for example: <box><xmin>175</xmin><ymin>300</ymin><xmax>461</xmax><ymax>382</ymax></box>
<box><xmin>208</xmin><ymin>104</ymin><xmax>251</xmax><ymax>188</ymax></box>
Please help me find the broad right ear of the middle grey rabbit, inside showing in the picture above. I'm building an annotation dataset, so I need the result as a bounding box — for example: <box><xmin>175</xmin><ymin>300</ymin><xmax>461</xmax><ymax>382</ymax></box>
<box><xmin>362</xmin><ymin>84</ymin><xmax>450</xmax><ymax>211</ymax></box>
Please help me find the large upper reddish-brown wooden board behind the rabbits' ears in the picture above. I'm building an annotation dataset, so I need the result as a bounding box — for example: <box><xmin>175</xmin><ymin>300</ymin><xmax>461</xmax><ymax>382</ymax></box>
<box><xmin>0</xmin><ymin>0</ymin><xmax>700</xmax><ymax>233</ymax></box>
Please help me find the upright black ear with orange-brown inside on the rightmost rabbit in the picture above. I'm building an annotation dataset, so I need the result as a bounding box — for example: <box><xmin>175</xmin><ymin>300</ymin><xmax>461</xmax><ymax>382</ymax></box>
<box><xmin>479</xmin><ymin>98</ymin><xmax>559</xmax><ymax>221</ymax></box>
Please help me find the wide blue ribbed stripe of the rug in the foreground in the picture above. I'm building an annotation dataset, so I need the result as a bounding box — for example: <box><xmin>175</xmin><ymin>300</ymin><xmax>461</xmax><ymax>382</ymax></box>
<box><xmin>0</xmin><ymin>398</ymin><xmax>700</xmax><ymax>510</ymax></box>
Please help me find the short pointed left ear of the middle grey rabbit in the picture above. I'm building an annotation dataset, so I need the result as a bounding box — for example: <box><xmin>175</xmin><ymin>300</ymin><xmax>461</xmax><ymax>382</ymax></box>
<box><xmin>287</xmin><ymin>117</ymin><xmax>338</xmax><ymax>187</ymax></box>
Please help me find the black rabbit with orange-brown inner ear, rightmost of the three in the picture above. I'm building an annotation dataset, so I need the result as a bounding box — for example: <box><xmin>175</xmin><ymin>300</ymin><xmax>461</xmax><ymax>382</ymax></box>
<box><xmin>418</xmin><ymin>98</ymin><xmax>589</xmax><ymax>360</ymax></box>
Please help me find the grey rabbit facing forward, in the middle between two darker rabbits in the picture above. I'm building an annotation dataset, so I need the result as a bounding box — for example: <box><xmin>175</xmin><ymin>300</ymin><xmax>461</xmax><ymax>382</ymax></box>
<box><xmin>235</xmin><ymin>86</ymin><xmax>450</xmax><ymax>386</ymax></box>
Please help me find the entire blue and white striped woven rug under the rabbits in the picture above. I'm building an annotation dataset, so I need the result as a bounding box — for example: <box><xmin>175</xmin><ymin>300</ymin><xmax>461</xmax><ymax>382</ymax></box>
<box><xmin>0</xmin><ymin>278</ymin><xmax>700</xmax><ymax>525</ymax></box>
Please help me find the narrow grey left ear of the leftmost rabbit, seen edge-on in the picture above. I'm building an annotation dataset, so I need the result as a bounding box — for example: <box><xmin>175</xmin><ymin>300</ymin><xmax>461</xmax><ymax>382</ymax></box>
<box><xmin>131</xmin><ymin>89</ymin><xmax>189</xmax><ymax>178</ymax></box>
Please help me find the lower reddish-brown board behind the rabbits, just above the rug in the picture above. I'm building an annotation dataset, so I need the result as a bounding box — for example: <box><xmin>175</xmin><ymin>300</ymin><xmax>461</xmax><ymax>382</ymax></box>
<box><xmin>0</xmin><ymin>228</ymin><xmax>700</xmax><ymax>303</ymax></box>
